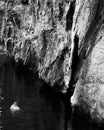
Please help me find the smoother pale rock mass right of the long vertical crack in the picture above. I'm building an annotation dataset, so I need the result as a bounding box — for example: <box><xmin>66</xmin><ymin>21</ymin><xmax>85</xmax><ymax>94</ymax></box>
<box><xmin>71</xmin><ymin>0</ymin><xmax>104</xmax><ymax>122</ymax></box>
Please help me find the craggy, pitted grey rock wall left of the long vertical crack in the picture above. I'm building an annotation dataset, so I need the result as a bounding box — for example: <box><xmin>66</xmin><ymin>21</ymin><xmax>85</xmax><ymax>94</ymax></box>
<box><xmin>1</xmin><ymin>0</ymin><xmax>75</xmax><ymax>92</ymax></box>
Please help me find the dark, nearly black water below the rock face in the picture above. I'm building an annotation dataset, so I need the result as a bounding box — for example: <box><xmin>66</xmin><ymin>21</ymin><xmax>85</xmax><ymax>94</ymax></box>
<box><xmin>0</xmin><ymin>56</ymin><xmax>103</xmax><ymax>130</ymax></box>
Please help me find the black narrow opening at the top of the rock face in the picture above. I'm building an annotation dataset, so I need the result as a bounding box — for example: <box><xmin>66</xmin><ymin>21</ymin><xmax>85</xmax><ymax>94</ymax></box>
<box><xmin>66</xmin><ymin>0</ymin><xmax>76</xmax><ymax>31</ymax></box>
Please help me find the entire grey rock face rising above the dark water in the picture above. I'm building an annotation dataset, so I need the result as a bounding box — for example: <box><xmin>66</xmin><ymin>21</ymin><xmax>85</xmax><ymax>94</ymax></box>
<box><xmin>0</xmin><ymin>0</ymin><xmax>104</xmax><ymax>121</ymax></box>
